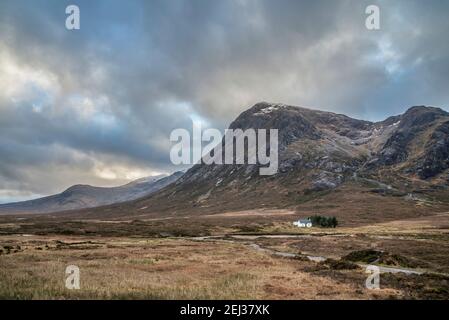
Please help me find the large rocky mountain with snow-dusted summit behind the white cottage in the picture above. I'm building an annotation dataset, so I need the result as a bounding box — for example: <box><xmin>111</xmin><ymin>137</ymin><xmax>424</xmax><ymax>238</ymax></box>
<box><xmin>22</xmin><ymin>102</ymin><xmax>449</xmax><ymax>221</ymax></box>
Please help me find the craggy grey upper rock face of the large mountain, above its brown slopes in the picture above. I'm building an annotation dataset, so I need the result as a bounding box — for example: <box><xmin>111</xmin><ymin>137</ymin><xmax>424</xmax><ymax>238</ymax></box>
<box><xmin>181</xmin><ymin>102</ymin><xmax>449</xmax><ymax>197</ymax></box>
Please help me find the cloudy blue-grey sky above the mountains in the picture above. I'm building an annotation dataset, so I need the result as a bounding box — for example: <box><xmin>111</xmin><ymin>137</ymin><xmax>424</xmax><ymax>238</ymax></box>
<box><xmin>0</xmin><ymin>0</ymin><xmax>449</xmax><ymax>203</ymax></box>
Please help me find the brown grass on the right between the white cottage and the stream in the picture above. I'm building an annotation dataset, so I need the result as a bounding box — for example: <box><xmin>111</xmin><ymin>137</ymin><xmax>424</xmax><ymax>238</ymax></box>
<box><xmin>248</xmin><ymin>213</ymin><xmax>449</xmax><ymax>274</ymax></box>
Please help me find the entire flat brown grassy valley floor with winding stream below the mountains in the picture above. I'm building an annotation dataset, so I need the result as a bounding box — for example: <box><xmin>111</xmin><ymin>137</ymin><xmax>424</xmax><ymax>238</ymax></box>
<box><xmin>0</xmin><ymin>212</ymin><xmax>449</xmax><ymax>299</ymax></box>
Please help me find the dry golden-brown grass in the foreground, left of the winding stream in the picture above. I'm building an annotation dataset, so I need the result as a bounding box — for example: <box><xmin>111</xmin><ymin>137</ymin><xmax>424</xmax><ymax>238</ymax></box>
<box><xmin>0</xmin><ymin>236</ymin><xmax>400</xmax><ymax>299</ymax></box>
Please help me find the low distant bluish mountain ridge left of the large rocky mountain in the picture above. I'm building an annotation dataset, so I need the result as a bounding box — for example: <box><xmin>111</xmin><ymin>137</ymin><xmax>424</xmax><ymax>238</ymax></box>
<box><xmin>0</xmin><ymin>172</ymin><xmax>183</xmax><ymax>214</ymax></box>
